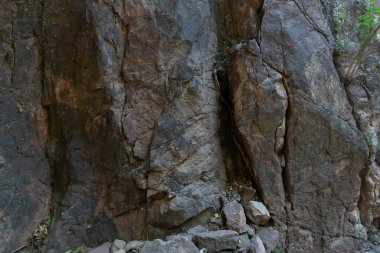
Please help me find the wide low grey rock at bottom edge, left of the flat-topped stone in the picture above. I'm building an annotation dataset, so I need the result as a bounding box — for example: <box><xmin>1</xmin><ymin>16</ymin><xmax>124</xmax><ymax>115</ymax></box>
<box><xmin>140</xmin><ymin>238</ymin><xmax>199</xmax><ymax>253</ymax></box>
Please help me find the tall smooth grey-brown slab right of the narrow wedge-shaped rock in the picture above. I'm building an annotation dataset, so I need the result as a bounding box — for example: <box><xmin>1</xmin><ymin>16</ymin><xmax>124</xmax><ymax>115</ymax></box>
<box><xmin>260</xmin><ymin>0</ymin><xmax>365</xmax><ymax>252</ymax></box>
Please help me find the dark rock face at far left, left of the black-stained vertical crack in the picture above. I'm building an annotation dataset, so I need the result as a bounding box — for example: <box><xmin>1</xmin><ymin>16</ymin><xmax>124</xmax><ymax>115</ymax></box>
<box><xmin>0</xmin><ymin>0</ymin><xmax>51</xmax><ymax>252</ymax></box>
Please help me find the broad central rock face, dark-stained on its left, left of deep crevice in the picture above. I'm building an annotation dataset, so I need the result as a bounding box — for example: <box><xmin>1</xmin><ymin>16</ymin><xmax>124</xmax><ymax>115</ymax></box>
<box><xmin>40</xmin><ymin>0</ymin><xmax>226</xmax><ymax>251</ymax></box>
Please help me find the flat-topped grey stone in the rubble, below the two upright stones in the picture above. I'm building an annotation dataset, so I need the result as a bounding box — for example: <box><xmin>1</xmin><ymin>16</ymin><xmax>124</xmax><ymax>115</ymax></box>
<box><xmin>193</xmin><ymin>230</ymin><xmax>239</xmax><ymax>252</ymax></box>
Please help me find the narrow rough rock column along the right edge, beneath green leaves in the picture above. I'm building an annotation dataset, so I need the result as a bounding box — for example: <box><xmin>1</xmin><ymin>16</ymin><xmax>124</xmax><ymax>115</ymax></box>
<box><xmin>327</xmin><ymin>1</ymin><xmax>380</xmax><ymax>229</ymax></box>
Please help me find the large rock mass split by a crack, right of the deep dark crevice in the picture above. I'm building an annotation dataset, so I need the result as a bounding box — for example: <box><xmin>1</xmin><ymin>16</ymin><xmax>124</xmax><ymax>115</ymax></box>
<box><xmin>229</xmin><ymin>0</ymin><xmax>372</xmax><ymax>252</ymax></box>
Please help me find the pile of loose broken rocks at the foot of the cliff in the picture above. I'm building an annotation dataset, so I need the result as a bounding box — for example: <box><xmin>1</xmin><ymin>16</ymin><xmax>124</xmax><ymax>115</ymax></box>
<box><xmin>77</xmin><ymin>188</ymin><xmax>283</xmax><ymax>253</ymax></box>
